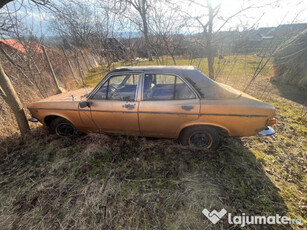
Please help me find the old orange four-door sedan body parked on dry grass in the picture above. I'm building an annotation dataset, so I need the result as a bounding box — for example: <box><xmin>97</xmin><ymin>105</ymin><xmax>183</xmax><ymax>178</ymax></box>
<box><xmin>28</xmin><ymin>66</ymin><xmax>275</xmax><ymax>148</ymax></box>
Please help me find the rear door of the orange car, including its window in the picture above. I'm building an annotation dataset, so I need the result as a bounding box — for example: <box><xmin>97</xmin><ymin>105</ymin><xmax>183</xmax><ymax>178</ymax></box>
<box><xmin>139</xmin><ymin>73</ymin><xmax>200</xmax><ymax>137</ymax></box>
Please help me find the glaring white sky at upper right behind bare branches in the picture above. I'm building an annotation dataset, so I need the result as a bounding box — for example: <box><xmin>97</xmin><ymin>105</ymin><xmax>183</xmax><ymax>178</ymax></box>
<box><xmin>181</xmin><ymin>0</ymin><xmax>307</xmax><ymax>30</ymax></box>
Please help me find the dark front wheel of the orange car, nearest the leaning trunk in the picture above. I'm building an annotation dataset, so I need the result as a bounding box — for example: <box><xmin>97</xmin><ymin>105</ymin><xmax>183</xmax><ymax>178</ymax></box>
<box><xmin>49</xmin><ymin>117</ymin><xmax>80</xmax><ymax>136</ymax></box>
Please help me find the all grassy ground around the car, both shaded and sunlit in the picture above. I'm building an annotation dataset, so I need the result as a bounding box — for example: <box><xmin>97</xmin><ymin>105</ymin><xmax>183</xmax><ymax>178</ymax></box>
<box><xmin>0</xmin><ymin>56</ymin><xmax>307</xmax><ymax>229</ymax></box>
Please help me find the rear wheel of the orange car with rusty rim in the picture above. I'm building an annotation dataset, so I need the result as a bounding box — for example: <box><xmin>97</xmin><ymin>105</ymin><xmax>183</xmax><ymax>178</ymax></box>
<box><xmin>179</xmin><ymin>126</ymin><xmax>221</xmax><ymax>150</ymax></box>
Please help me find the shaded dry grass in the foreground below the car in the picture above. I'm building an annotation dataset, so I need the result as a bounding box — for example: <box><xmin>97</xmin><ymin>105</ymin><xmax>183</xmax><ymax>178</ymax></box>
<box><xmin>0</xmin><ymin>128</ymin><xmax>288</xmax><ymax>229</ymax></box>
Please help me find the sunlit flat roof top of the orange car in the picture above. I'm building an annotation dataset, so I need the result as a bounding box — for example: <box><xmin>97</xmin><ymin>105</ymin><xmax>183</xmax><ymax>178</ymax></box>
<box><xmin>111</xmin><ymin>65</ymin><xmax>197</xmax><ymax>72</ymax></box>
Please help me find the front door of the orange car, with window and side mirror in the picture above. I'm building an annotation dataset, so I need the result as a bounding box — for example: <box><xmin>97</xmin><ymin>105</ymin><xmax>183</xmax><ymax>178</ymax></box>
<box><xmin>89</xmin><ymin>73</ymin><xmax>140</xmax><ymax>135</ymax></box>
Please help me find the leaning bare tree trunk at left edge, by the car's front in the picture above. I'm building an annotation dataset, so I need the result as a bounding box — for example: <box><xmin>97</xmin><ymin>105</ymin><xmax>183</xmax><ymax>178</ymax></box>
<box><xmin>0</xmin><ymin>62</ymin><xmax>30</xmax><ymax>136</ymax></box>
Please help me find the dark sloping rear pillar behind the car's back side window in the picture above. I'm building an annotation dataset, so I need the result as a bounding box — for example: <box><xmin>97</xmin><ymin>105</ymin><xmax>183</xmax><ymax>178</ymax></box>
<box><xmin>185</xmin><ymin>70</ymin><xmax>240</xmax><ymax>99</ymax></box>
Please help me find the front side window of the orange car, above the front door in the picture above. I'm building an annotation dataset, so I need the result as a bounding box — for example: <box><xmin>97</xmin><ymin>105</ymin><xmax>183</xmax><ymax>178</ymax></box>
<box><xmin>93</xmin><ymin>74</ymin><xmax>139</xmax><ymax>101</ymax></box>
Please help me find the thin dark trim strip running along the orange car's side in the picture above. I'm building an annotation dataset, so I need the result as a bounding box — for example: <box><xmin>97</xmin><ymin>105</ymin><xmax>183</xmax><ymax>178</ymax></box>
<box><xmin>31</xmin><ymin>108</ymin><xmax>268</xmax><ymax>117</ymax></box>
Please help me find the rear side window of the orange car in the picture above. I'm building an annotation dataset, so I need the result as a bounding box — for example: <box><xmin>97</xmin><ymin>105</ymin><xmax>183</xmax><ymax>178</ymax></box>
<box><xmin>143</xmin><ymin>74</ymin><xmax>196</xmax><ymax>101</ymax></box>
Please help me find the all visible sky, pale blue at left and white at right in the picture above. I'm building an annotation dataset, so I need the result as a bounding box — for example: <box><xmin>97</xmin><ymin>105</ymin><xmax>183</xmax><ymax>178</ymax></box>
<box><xmin>0</xmin><ymin>0</ymin><xmax>307</xmax><ymax>37</ymax></box>
